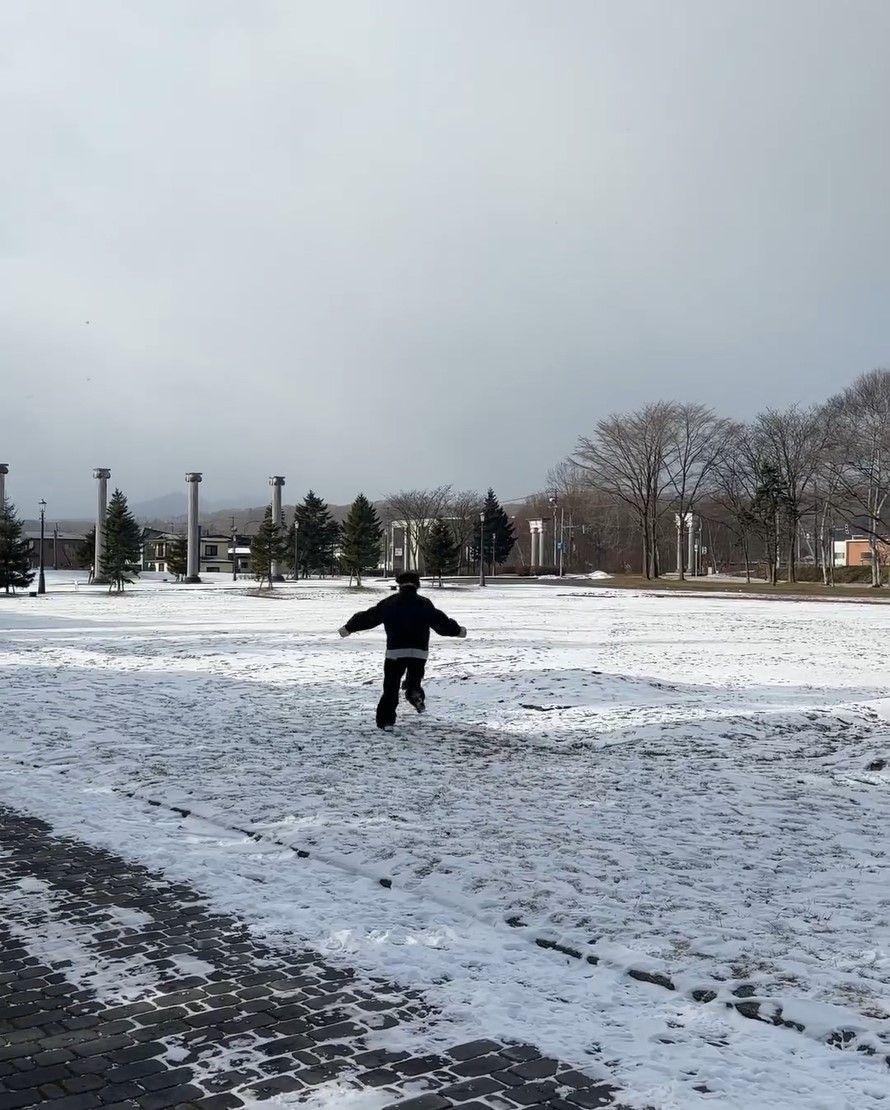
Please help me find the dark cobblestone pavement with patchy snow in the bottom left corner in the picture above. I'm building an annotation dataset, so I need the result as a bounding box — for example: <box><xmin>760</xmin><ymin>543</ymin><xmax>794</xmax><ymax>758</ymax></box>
<box><xmin>0</xmin><ymin>807</ymin><xmax>617</xmax><ymax>1110</ymax></box>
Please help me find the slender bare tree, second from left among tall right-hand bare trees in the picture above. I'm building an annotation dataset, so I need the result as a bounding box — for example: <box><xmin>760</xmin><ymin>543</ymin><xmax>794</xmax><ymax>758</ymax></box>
<box><xmin>665</xmin><ymin>402</ymin><xmax>731</xmax><ymax>581</ymax></box>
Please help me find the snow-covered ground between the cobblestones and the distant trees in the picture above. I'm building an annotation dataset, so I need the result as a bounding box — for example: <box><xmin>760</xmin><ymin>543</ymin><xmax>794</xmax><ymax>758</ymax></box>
<box><xmin>0</xmin><ymin>583</ymin><xmax>890</xmax><ymax>1108</ymax></box>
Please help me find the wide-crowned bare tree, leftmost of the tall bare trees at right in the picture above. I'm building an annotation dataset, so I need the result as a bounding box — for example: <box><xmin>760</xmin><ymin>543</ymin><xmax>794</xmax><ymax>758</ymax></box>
<box><xmin>573</xmin><ymin>401</ymin><xmax>676</xmax><ymax>578</ymax></box>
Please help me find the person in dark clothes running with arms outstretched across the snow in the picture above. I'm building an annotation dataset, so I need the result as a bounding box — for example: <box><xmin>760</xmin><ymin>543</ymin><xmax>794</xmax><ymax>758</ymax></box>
<box><xmin>340</xmin><ymin>571</ymin><xmax>466</xmax><ymax>731</ymax></box>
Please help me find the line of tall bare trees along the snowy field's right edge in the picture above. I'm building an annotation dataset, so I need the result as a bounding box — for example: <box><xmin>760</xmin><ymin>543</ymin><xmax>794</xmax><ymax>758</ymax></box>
<box><xmin>534</xmin><ymin>370</ymin><xmax>890</xmax><ymax>586</ymax></box>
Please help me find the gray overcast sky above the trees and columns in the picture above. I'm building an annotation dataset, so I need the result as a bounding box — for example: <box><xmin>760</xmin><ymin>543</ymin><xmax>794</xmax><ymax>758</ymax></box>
<box><xmin>0</xmin><ymin>0</ymin><xmax>890</xmax><ymax>516</ymax></box>
